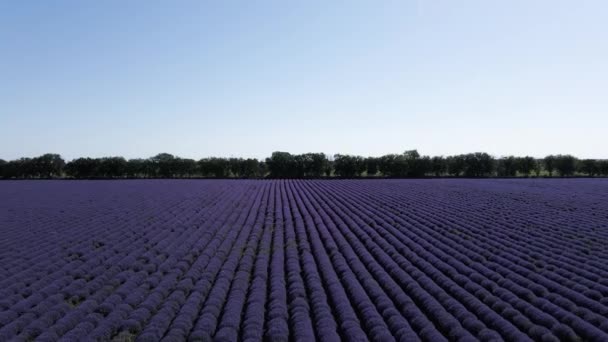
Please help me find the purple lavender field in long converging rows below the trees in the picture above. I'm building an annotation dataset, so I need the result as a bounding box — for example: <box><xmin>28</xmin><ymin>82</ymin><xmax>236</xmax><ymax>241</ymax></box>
<box><xmin>0</xmin><ymin>179</ymin><xmax>608</xmax><ymax>341</ymax></box>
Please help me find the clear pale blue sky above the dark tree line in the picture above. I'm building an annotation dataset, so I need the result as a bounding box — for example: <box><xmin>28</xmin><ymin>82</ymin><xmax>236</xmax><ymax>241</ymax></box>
<box><xmin>0</xmin><ymin>0</ymin><xmax>608</xmax><ymax>159</ymax></box>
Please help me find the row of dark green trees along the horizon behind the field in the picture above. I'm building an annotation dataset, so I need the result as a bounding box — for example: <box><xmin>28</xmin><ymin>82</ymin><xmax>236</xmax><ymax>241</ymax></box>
<box><xmin>0</xmin><ymin>150</ymin><xmax>608</xmax><ymax>179</ymax></box>
